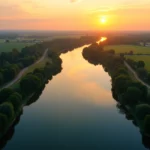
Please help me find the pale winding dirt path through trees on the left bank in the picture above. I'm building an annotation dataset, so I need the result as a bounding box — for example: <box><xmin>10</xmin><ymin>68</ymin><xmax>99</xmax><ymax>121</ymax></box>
<box><xmin>0</xmin><ymin>49</ymin><xmax>48</xmax><ymax>90</ymax></box>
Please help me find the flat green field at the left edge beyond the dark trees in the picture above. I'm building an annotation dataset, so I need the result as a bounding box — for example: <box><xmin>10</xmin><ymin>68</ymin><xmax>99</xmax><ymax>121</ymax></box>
<box><xmin>0</xmin><ymin>42</ymin><xmax>33</xmax><ymax>52</ymax></box>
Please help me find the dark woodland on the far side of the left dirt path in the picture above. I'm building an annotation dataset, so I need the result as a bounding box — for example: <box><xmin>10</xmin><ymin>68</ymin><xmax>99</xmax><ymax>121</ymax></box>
<box><xmin>0</xmin><ymin>44</ymin><xmax>44</xmax><ymax>86</ymax></box>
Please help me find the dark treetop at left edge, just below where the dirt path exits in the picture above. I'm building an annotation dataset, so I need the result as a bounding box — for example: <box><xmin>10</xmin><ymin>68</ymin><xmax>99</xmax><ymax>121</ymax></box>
<box><xmin>0</xmin><ymin>88</ymin><xmax>14</xmax><ymax>104</ymax></box>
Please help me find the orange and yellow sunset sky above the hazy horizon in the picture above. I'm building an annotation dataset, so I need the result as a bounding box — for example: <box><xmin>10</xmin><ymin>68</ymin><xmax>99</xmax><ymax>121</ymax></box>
<box><xmin>0</xmin><ymin>0</ymin><xmax>150</xmax><ymax>30</ymax></box>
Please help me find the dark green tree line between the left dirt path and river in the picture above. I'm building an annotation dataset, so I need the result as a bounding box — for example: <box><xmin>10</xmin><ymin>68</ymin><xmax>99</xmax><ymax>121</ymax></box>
<box><xmin>0</xmin><ymin>53</ymin><xmax>62</xmax><ymax>136</ymax></box>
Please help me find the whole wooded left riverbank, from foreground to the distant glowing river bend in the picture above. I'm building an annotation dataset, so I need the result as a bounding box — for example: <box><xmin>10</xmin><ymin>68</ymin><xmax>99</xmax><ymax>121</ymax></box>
<box><xmin>0</xmin><ymin>38</ymin><xmax>98</xmax><ymax>141</ymax></box>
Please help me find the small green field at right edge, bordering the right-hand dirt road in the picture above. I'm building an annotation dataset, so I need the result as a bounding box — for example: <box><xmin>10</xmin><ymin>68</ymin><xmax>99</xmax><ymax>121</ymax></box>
<box><xmin>126</xmin><ymin>55</ymin><xmax>150</xmax><ymax>72</ymax></box>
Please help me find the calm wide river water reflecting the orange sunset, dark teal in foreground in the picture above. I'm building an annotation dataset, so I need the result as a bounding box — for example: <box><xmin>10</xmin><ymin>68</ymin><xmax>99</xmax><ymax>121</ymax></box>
<box><xmin>4</xmin><ymin>47</ymin><xmax>145</xmax><ymax>150</ymax></box>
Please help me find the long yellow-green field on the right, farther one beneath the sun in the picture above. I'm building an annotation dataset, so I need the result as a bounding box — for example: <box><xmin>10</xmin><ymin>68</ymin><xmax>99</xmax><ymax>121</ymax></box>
<box><xmin>105</xmin><ymin>45</ymin><xmax>150</xmax><ymax>54</ymax></box>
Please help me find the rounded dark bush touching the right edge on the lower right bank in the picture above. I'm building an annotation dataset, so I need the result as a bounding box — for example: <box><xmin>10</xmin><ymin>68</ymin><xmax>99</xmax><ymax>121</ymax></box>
<box><xmin>136</xmin><ymin>104</ymin><xmax>150</xmax><ymax>120</ymax></box>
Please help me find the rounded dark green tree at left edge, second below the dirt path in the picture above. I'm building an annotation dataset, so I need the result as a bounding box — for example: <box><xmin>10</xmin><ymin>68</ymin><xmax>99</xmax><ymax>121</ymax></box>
<box><xmin>0</xmin><ymin>102</ymin><xmax>14</xmax><ymax>120</ymax></box>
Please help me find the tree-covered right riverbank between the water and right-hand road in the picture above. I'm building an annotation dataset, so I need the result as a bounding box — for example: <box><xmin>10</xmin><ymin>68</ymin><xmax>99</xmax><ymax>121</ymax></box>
<box><xmin>83</xmin><ymin>44</ymin><xmax>150</xmax><ymax>136</ymax></box>
